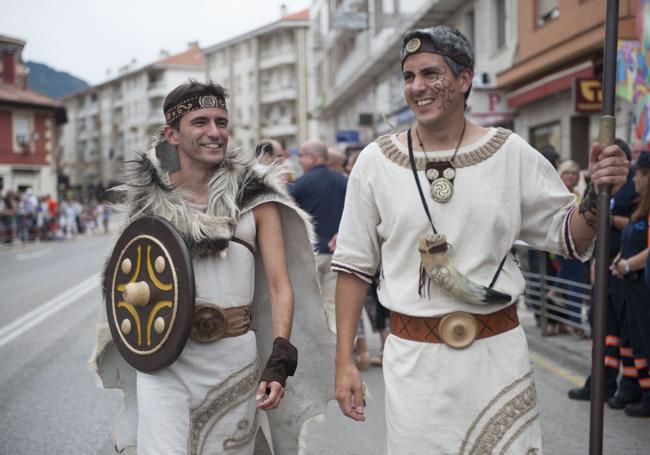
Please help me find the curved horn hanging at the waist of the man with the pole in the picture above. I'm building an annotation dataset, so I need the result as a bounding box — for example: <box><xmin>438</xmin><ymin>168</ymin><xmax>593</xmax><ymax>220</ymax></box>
<box><xmin>418</xmin><ymin>234</ymin><xmax>511</xmax><ymax>304</ymax></box>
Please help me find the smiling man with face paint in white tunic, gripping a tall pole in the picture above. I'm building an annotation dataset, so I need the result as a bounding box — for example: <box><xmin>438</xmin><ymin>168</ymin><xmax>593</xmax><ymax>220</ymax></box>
<box><xmin>332</xmin><ymin>26</ymin><xmax>628</xmax><ymax>455</ymax></box>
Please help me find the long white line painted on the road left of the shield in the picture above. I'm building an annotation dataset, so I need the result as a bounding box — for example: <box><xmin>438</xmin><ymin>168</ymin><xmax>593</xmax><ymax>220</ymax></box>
<box><xmin>0</xmin><ymin>273</ymin><xmax>100</xmax><ymax>348</ymax></box>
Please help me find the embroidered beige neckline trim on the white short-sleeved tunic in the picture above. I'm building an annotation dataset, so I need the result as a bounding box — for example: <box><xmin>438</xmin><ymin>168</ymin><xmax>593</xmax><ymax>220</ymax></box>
<box><xmin>376</xmin><ymin>128</ymin><xmax>512</xmax><ymax>171</ymax></box>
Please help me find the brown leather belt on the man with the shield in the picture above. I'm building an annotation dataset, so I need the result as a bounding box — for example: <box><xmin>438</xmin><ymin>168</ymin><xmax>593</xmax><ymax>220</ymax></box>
<box><xmin>190</xmin><ymin>303</ymin><xmax>251</xmax><ymax>343</ymax></box>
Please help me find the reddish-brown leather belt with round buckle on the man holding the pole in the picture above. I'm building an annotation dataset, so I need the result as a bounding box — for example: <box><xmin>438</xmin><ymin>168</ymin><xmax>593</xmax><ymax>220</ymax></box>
<box><xmin>390</xmin><ymin>304</ymin><xmax>519</xmax><ymax>349</ymax></box>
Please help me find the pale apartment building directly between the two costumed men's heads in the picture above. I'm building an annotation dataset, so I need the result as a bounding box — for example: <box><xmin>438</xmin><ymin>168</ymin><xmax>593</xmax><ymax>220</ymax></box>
<box><xmin>204</xmin><ymin>10</ymin><xmax>310</xmax><ymax>151</ymax></box>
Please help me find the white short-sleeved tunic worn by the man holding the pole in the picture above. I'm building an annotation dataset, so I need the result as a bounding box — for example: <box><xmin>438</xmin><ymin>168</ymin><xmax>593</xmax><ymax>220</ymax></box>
<box><xmin>332</xmin><ymin>128</ymin><xmax>591</xmax><ymax>455</ymax></box>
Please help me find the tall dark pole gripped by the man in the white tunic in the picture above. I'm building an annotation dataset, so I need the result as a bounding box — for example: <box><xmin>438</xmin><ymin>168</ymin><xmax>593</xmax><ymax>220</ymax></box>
<box><xmin>589</xmin><ymin>0</ymin><xmax>618</xmax><ymax>455</ymax></box>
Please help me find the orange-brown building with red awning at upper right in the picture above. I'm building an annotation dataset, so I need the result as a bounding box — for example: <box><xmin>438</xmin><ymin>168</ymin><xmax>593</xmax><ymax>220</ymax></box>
<box><xmin>497</xmin><ymin>0</ymin><xmax>637</xmax><ymax>168</ymax></box>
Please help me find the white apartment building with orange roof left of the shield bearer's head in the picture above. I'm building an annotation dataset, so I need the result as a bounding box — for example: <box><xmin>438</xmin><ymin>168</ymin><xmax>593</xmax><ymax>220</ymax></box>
<box><xmin>61</xmin><ymin>42</ymin><xmax>205</xmax><ymax>199</ymax></box>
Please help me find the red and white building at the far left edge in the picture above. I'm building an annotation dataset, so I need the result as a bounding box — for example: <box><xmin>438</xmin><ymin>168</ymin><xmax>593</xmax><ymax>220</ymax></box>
<box><xmin>0</xmin><ymin>35</ymin><xmax>66</xmax><ymax>197</ymax></box>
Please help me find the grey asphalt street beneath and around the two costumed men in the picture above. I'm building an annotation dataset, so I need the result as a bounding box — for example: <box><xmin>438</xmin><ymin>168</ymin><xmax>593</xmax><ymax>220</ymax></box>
<box><xmin>0</xmin><ymin>236</ymin><xmax>650</xmax><ymax>455</ymax></box>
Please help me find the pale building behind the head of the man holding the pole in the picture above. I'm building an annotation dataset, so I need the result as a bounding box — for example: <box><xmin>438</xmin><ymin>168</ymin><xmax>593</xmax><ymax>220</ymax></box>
<box><xmin>311</xmin><ymin>0</ymin><xmax>517</xmax><ymax>148</ymax></box>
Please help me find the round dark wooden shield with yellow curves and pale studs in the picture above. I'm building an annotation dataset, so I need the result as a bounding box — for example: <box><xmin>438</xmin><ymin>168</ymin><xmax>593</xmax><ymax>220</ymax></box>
<box><xmin>104</xmin><ymin>217</ymin><xmax>195</xmax><ymax>372</ymax></box>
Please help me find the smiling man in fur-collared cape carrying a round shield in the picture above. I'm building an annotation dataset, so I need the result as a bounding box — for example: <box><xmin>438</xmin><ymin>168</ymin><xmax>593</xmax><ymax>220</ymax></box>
<box><xmin>92</xmin><ymin>80</ymin><xmax>332</xmax><ymax>455</ymax></box>
